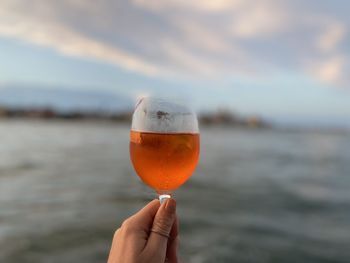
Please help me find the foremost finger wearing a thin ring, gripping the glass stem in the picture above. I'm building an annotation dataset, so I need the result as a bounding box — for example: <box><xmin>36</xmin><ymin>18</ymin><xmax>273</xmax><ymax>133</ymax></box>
<box><xmin>145</xmin><ymin>199</ymin><xmax>176</xmax><ymax>262</ymax></box>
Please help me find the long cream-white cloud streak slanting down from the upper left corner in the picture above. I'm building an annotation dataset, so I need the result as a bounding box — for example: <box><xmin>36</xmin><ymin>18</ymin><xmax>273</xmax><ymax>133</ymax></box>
<box><xmin>0</xmin><ymin>1</ymin><xmax>158</xmax><ymax>75</ymax></box>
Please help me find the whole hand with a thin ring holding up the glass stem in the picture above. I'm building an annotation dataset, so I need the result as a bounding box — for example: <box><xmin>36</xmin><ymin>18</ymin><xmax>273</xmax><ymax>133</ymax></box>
<box><xmin>108</xmin><ymin>199</ymin><xmax>178</xmax><ymax>263</ymax></box>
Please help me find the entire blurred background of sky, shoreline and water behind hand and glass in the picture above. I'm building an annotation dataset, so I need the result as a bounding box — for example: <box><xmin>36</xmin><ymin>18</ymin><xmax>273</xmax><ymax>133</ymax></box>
<box><xmin>0</xmin><ymin>0</ymin><xmax>350</xmax><ymax>263</ymax></box>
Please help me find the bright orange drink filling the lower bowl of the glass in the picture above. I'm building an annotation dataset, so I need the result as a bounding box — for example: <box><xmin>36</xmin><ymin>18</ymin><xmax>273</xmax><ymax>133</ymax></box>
<box><xmin>130</xmin><ymin>130</ymin><xmax>199</xmax><ymax>192</ymax></box>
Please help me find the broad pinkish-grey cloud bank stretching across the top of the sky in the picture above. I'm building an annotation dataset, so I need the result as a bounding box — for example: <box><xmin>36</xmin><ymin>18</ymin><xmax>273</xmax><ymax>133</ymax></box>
<box><xmin>0</xmin><ymin>0</ymin><xmax>350</xmax><ymax>86</ymax></box>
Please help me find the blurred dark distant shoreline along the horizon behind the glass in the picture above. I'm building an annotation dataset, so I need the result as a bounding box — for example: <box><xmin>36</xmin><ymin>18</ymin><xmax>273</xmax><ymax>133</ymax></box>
<box><xmin>0</xmin><ymin>106</ymin><xmax>350</xmax><ymax>134</ymax></box>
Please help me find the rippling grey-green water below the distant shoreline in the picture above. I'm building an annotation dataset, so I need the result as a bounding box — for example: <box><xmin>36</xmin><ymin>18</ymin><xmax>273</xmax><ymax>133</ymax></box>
<box><xmin>0</xmin><ymin>120</ymin><xmax>350</xmax><ymax>263</ymax></box>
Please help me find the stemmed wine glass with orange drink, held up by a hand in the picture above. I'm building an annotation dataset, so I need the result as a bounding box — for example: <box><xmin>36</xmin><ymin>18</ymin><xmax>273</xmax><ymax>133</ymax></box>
<box><xmin>130</xmin><ymin>97</ymin><xmax>199</xmax><ymax>203</ymax></box>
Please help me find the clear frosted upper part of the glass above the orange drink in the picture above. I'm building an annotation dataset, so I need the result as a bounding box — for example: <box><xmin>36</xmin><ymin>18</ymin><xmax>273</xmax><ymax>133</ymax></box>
<box><xmin>131</xmin><ymin>97</ymin><xmax>199</xmax><ymax>133</ymax></box>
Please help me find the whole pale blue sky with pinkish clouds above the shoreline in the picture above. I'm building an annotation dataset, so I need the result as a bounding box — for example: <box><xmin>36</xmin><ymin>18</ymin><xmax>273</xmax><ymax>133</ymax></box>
<box><xmin>0</xmin><ymin>0</ymin><xmax>350</xmax><ymax>126</ymax></box>
